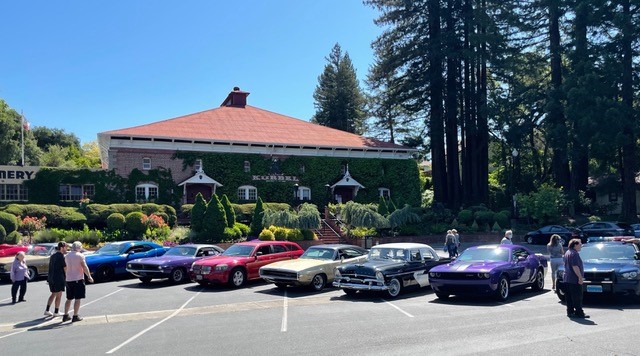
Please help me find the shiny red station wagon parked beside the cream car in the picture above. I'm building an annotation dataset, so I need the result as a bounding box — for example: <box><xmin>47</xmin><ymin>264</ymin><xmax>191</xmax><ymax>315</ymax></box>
<box><xmin>189</xmin><ymin>241</ymin><xmax>304</xmax><ymax>288</ymax></box>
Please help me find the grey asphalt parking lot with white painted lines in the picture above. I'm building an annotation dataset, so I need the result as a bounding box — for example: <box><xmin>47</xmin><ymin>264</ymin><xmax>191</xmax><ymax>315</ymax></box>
<box><xmin>0</xmin><ymin>243</ymin><xmax>640</xmax><ymax>355</ymax></box>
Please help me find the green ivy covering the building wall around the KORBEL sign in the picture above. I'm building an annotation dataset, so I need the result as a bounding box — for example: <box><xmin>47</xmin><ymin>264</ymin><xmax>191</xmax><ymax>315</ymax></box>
<box><xmin>174</xmin><ymin>152</ymin><xmax>420</xmax><ymax>207</ymax></box>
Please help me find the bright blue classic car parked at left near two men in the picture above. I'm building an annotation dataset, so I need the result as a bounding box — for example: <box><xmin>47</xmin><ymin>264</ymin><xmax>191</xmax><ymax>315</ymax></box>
<box><xmin>86</xmin><ymin>241</ymin><xmax>167</xmax><ymax>282</ymax></box>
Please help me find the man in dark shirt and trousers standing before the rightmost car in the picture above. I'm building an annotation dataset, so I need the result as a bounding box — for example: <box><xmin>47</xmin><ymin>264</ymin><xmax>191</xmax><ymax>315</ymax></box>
<box><xmin>562</xmin><ymin>239</ymin><xmax>589</xmax><ymax>318</ymax></box>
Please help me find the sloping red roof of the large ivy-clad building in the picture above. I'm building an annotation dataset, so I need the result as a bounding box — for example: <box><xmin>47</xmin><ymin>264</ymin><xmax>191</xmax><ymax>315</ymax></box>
<box><xmin>101</xmin><ymin>105</ymin><xmax>409</xmax><ymax>149</ymax></box>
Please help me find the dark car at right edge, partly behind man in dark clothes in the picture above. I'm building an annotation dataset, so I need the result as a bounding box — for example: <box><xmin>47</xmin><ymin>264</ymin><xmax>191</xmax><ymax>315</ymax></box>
<box><xmin>556</xmin><ymin>241</ymin><xmax>640</xmax><ymax>301</ymax></box>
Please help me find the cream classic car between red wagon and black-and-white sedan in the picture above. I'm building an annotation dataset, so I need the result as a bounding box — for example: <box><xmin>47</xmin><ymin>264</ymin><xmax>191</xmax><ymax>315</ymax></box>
<box><xmin>260</xmin><ymin>244</ymin><xmax>367</xmax><ymax>291</ymax></box>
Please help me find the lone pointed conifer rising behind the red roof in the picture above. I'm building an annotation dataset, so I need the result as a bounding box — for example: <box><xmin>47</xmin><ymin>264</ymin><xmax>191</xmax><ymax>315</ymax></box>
<box><xmin>313</xmin><ymin>43</ymin><xmax>366</xmax><ymax>134</ymax></box>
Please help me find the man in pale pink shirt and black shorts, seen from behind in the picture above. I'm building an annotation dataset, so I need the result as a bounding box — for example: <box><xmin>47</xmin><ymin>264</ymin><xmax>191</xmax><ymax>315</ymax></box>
<box><xmin>62</xmin><ymin>241</ymin><xmax>93</xmax><ymax>323</ymax></box>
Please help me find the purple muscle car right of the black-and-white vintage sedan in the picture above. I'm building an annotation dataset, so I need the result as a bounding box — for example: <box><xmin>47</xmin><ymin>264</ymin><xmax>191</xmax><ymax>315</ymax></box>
<box><xmin>429</xmin><ymin>245</ymin><xmax>548</xmax><ymax>301</ymax></box>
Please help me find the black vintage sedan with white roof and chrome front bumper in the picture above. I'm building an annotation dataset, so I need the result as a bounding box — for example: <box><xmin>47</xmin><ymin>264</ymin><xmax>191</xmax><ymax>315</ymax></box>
<box><xmin>333</xmin><ymin>243</ymin><xmax>451</xmax><ymax>298</ymax></box>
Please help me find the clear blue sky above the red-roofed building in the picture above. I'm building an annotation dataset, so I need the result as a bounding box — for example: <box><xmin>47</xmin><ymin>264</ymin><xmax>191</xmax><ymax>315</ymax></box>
<box><xmin>0</xmin><ymin>0</ymin><xmax>382</xmax><ymax>143</ymax></box>
